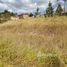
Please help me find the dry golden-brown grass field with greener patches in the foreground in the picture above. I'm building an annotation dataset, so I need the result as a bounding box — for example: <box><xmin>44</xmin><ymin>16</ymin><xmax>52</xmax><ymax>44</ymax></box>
<box><xmin>0</xmin><ymin>16</ymin><xmax>67</xmax><ymax>67</ymax></box>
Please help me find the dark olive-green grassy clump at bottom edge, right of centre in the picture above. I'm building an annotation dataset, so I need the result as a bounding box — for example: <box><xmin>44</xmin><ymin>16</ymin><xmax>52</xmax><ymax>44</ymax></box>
<box><xmin>44</xmin><ymin>56</ymin><xmax>65</xmax><ymax>67</ymax></box>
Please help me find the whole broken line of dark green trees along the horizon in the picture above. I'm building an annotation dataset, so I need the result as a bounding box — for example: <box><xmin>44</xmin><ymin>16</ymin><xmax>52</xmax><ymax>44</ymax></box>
<box><xmin>0</xmin><ymin>0</ymin><xmax>67</xmax><ymax>23</ymax></box>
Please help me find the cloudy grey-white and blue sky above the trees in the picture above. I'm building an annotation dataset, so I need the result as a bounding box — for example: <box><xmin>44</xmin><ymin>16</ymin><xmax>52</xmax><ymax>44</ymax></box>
<box><xmin>0</xmin><ymin>0</ymin><xmax>64</xmax><ymax>13</ymax></box>
